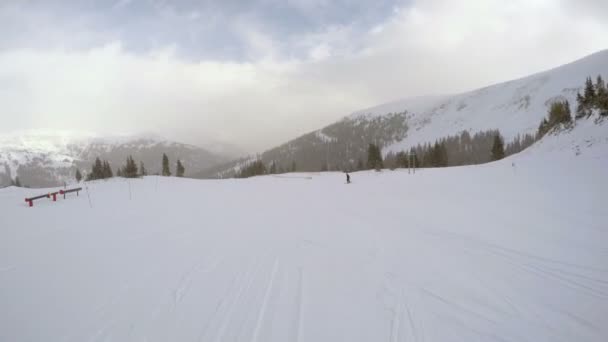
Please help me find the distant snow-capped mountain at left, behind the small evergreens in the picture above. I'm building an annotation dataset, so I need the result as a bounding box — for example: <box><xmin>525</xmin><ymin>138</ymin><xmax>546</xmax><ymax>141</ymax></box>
<box><xmin>0</xmin><ymin>131</ymin><xmax>226</xmax><ymax>187</ymax></box>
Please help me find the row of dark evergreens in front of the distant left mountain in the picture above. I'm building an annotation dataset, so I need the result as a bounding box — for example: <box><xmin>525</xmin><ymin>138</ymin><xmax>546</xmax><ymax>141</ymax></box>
<box><xmin>79</xmin><ymin>153</ymin><xmax>186</xmax><ymax>182</ymax></box>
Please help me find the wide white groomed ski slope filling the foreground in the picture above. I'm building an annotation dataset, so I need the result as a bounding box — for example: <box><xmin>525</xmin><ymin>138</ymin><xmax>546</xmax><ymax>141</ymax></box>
<box><xmin>0</xmin><ymin>130</ymin><xmax>608</xmax><ymax>342</ymax></box>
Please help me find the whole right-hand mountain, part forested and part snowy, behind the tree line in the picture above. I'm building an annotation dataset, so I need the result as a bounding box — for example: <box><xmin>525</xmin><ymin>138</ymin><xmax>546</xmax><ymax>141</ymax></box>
<box><xmin>202</xmin><ymin>50</ymin><xmax>608</xmax><ymax>177</ymax></box>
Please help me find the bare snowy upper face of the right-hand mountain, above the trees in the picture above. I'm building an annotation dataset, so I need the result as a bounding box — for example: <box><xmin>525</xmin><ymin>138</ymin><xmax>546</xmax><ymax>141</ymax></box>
<box><xmin>351</xmin><ymin>50</ymin><xmax>608</xmax><ymax>152</ymax></box>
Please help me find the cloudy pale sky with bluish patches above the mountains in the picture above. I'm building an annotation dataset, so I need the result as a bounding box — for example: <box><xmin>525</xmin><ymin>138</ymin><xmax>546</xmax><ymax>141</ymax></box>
<box><xmin>0</xmin><ymin>0</ymin><xmax>608</xmax><ymax>152</ymax></box>
